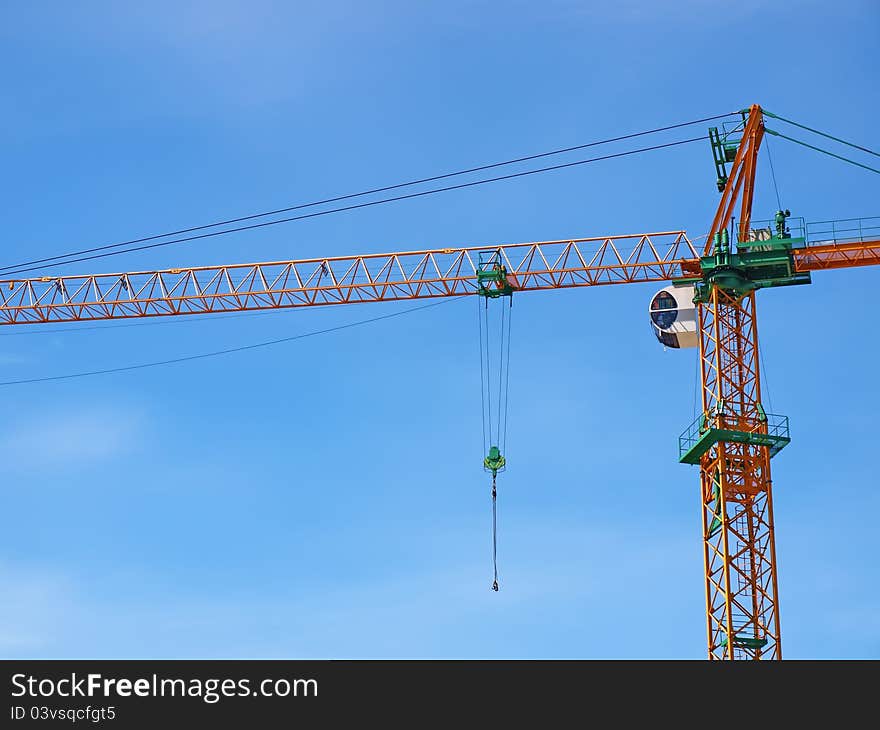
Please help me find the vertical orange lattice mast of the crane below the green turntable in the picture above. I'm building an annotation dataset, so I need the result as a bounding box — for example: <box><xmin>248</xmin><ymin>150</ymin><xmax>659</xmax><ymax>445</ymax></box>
<box><xmin>699</xmin><ymin>287</ymin><xmax>782</xmax><ymax>659</ymax></box>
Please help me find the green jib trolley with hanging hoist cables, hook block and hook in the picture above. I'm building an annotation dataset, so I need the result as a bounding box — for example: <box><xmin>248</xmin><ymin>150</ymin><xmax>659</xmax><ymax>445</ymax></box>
<box><xmin>477</xmin><ymin>250</ymin><xmax>513</xmax><ymax>591</ymax></box>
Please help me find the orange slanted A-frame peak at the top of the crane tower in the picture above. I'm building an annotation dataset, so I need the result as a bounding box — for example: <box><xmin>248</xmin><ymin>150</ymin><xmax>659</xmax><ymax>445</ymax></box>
<box><xmin>703</xmin><ymin>104</ymin><xmax>764</xmax><ymax>255</ymax></box>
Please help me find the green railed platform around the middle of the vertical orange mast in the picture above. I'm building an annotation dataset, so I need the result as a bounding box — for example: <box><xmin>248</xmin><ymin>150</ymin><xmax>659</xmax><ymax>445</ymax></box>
<box><xmin>678</xmin><ymin>408</ymin><xmax>791</xmax><ymax>464</ymax></box>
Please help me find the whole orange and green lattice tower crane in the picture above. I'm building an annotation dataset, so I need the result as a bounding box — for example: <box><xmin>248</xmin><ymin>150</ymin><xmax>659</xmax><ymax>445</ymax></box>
<box><xmin>0</xmin><ymin>105</ymin><xmax>880</xmax><ymax>659</ymax></box>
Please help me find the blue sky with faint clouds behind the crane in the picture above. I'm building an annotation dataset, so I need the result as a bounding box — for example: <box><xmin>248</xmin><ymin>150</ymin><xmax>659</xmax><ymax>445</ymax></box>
<box><xmin>0</xmin><ymin>0</ymin><xmax>880</xmax><ymax>658</ymax></box>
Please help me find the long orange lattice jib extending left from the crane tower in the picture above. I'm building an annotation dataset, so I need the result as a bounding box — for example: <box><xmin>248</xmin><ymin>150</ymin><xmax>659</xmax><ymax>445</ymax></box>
<box><xmin>0</xmin><ymin>231</ymin><xmax>699</xmax><ymax>325</ymax></box>
